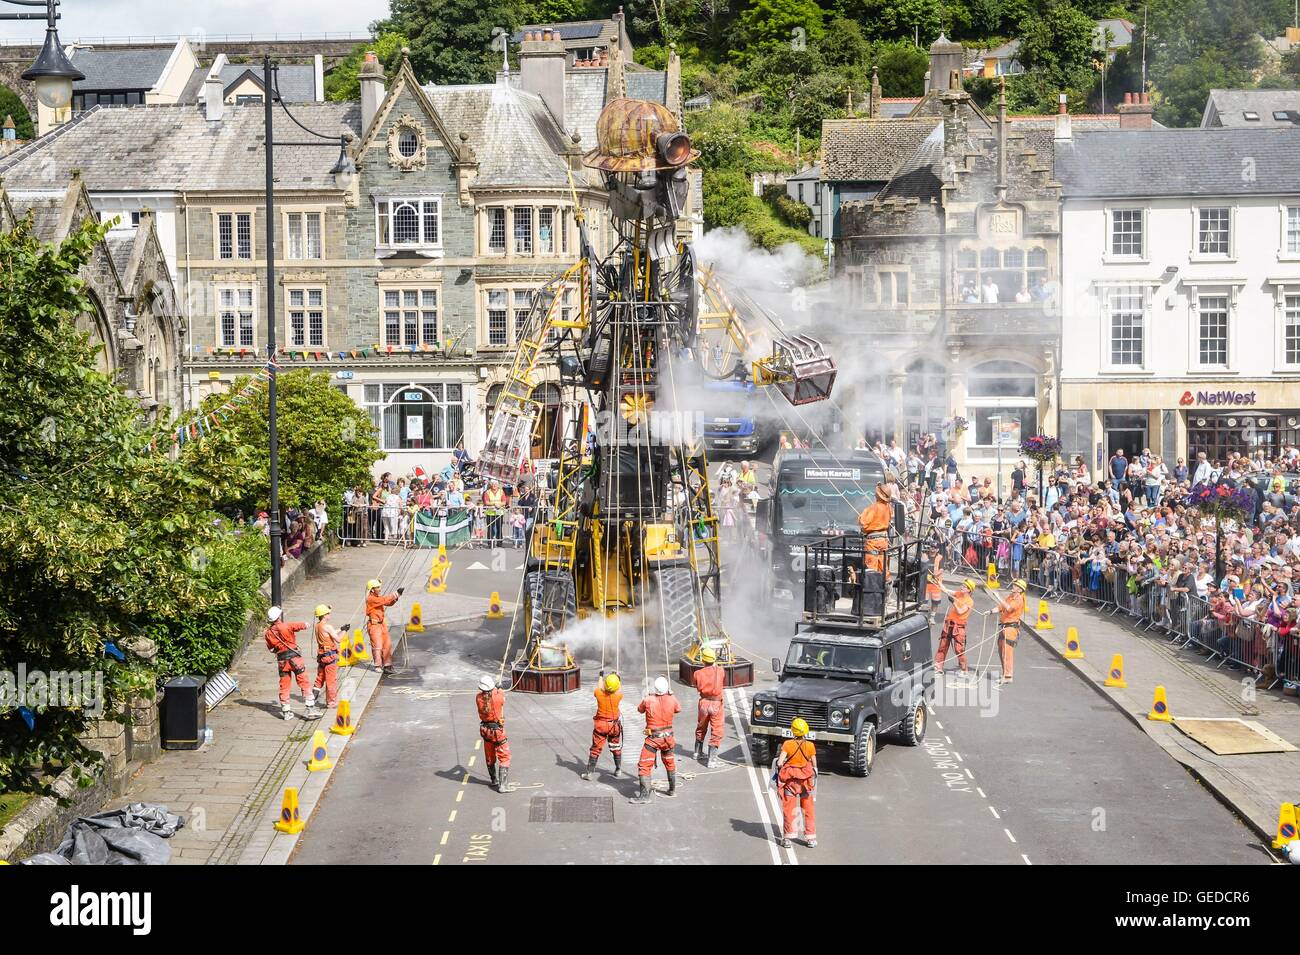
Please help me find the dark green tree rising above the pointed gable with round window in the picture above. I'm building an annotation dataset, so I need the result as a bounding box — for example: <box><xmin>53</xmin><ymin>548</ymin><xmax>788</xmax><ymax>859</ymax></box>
<box><xmin>376</xmin><ymin>0</ymin><xmax>527</xmax><ymax>83</ymax></box>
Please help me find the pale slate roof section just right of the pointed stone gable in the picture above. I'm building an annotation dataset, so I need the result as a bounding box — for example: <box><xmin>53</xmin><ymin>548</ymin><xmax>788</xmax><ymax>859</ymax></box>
<box><xmin>426</xmin><ymin>79</ymin><xmax>568</xmax><ymax>187</ymax></box>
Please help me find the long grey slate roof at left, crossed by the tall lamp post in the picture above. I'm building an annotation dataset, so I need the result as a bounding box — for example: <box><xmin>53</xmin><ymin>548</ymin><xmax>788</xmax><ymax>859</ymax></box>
<box><xmin>0</xmin><ymin>103</ymin><xmax>361</xmax><ymax>192</ymax></box>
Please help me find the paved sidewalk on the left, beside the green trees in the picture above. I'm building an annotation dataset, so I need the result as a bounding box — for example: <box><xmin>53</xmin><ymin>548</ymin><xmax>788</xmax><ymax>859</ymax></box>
<box><xmin>108</xmin><ymin>544</ymin><xmax>491</xmax><ymax>864</ymax></box>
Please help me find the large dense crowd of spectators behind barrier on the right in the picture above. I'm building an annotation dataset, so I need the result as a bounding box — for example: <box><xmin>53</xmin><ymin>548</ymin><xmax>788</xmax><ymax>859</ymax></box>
<box><xmin>899</xmin><ymin>443</ymin><xmax>1300</xmax><ymax>693</ymax></box>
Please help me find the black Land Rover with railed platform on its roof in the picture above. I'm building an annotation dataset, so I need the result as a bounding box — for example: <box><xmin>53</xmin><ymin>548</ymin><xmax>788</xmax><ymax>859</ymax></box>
<box><xmin>749</xmin><ymin>535</ymin><xmax>933</xmax><ymax>776</ymax></box>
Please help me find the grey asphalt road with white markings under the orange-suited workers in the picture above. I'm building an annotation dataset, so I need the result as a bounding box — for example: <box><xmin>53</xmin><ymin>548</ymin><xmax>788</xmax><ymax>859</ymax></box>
<box><xmin>294</xmin><ymin>570</ymin><xmax>1269</xmax><ymax>865</ymax></box>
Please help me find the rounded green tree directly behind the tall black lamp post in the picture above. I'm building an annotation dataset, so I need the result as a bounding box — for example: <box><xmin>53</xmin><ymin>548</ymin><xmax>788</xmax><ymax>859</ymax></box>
<box><xmin>181</xmin><ymin>368</ymin><xmax>384</xmax><ymax>513</ymax></box>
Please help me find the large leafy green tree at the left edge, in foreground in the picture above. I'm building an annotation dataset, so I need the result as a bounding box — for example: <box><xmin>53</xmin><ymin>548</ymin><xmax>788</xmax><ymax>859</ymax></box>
<box><xmin>0</xmin><ymin>218</ymin><xmax>211</xmax><ymax>791</ymax></box>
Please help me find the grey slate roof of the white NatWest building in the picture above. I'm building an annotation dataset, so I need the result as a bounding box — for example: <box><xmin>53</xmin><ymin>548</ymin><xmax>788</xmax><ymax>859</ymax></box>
<box><xmin>1056</xmin><ymin>127</ymin><xmax>1300</xmax><ymax>199</ymax></box>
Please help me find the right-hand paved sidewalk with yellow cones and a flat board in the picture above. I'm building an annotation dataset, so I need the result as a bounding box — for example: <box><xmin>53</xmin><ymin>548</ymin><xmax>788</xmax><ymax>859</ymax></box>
<box><xmin>1028</xmin><ymin>594</ymin><xmax>1300</xmax><ymax>841</ymax></box>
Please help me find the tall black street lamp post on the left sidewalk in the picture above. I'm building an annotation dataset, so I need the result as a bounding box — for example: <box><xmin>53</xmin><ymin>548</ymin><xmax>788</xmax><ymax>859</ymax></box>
<box><xmin>261</xmin><ymin>56</ymin><xmax>356</xmax><ymax>607</ymax></box>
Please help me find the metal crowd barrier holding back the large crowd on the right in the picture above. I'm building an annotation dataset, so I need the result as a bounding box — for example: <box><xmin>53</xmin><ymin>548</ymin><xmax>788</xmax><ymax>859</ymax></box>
<box><xmin>941</xmin><ymin>533</ymin><xmax>1300</xmax><ymax>689</ymax></box>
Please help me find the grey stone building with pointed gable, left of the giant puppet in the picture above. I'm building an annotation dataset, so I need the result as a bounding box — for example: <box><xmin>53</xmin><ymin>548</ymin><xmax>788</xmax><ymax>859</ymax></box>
<box><xmin>0</xmin><ymin>41</ymin><xmax>698</xmax><ymax>473</ymax></box>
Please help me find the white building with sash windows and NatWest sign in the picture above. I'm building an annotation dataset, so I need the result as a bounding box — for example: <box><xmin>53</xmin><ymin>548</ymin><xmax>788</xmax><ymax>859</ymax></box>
<box><xmin>1056</xmin><ymin>129</ymin><xmax>1300</xmax><ymax>473</ymax></box>
